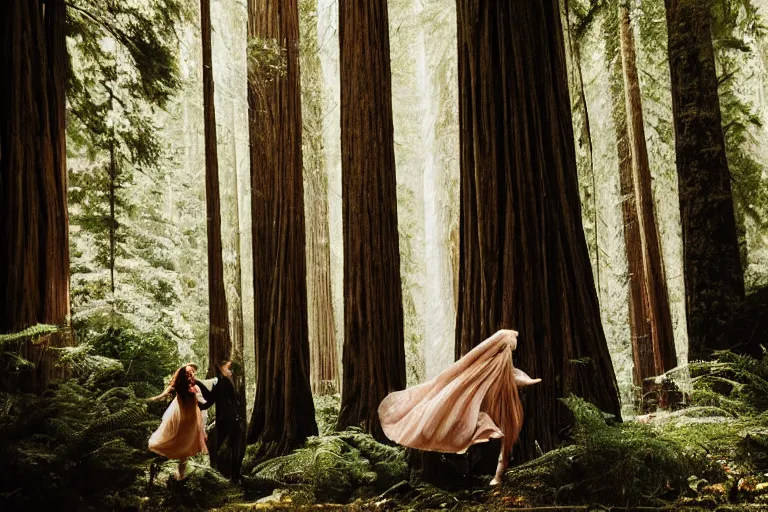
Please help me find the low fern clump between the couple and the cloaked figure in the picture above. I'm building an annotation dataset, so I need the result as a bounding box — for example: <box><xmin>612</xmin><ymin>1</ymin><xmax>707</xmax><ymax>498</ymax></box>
<box><xmin>243</xmin><ymin>429</ymin><xmax>408</xmax><ymax>502</ymax></box>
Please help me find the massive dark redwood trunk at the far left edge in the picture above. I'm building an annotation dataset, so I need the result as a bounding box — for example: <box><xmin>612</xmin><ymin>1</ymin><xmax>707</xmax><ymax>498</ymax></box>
<box><xmin>0</xmin><ymin>0</ymin><xmax>70</xmax><ymax>390</ymax></box>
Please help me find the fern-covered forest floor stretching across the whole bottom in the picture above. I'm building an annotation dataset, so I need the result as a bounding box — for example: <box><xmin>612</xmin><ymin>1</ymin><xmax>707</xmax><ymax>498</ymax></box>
<box><xmin>0</xmin><ymin>336</ymin><xmax>768</xmax><ymax>512</ymax></box>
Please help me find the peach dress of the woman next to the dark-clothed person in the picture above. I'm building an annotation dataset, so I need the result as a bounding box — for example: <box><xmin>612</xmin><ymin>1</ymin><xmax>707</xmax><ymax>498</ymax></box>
<box><xmin>149</xmin><ymin>396</ymin><xmax>208</xmax><ymax>460</ymax></box>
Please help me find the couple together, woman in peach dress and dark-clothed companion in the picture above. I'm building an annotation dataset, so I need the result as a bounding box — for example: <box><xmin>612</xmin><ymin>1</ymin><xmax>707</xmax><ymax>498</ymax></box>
<box><xmin>149</xmin><ymin>361</ymin><xmax>237</xmax><ymax>480</ymax></box>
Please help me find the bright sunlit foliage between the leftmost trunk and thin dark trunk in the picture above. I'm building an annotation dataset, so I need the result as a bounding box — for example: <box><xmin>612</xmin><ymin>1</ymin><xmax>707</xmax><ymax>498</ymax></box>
<box><xmin>67</xmin><ymin>0</ymin><xmax>196</xmax><ymax>341</ymax></box>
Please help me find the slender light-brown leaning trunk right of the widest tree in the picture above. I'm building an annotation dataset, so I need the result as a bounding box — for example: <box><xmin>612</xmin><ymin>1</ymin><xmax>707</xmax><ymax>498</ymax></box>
<box><xmin>619</xmin><ymin>4</ymin><xmax>677</xmax><ymax>390</ymax></box>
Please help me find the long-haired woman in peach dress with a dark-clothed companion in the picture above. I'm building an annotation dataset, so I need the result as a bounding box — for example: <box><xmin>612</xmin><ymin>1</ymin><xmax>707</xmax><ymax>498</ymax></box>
<box><xmin>149</xmin><ymin>364</ymin><xmax>208</xmax><ymax>480</ymax></box>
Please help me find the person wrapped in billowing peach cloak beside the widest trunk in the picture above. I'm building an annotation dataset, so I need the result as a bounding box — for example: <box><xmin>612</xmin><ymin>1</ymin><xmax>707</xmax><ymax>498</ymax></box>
<box><xmin>379</xmin><ymin>330</ymin><xmax>541</xmax><ymax>460</ymax></box>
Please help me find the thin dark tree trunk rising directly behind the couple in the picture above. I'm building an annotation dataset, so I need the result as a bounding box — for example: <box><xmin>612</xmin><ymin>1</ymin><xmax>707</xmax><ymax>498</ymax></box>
<box><xmin>200</xmin><ymin>0</ymin><xmax>232</xmax><ymax>470</ymax></box>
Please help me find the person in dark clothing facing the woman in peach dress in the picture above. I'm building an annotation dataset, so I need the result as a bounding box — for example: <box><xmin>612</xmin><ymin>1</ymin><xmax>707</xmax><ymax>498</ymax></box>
<box><xmin>196</xmin><ymin>361</ymin><xmax>241</xmax><ymax>480</ymax></box>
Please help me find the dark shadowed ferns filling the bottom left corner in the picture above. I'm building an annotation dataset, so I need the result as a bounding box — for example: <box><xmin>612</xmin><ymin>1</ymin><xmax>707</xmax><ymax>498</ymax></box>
<box><xmin>0</xmin><ymin>380</ymin><xmax>157</xmax><ymax>510</ymax></box>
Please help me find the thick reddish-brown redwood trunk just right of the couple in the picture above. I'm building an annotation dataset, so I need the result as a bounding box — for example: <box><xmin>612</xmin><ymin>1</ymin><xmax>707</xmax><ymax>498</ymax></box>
<box><xmin>248</xmin><ymin>0</ymin><xmax>317</xmax><ymax>455</ymax></box>
